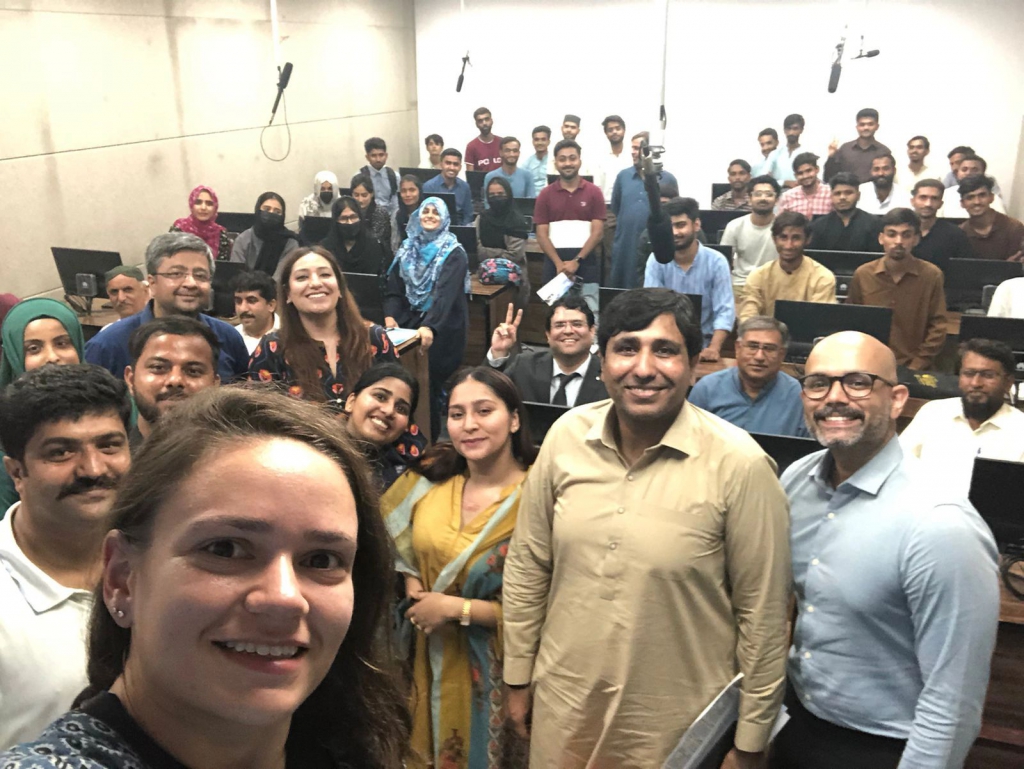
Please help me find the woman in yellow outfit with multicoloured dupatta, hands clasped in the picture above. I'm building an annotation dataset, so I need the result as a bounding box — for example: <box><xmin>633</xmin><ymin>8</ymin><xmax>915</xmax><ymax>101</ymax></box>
<box><xmin>381</xmin><ymin>367</ymin><xmax>537</xmax><ymax>769</ymax></box>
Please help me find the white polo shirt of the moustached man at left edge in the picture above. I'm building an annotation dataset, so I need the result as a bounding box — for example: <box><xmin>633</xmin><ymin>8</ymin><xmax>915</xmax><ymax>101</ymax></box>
<box><xmin>0</xmin><ymin>502</ymin><xmax>92</xmax><ymax>752</ymax></box>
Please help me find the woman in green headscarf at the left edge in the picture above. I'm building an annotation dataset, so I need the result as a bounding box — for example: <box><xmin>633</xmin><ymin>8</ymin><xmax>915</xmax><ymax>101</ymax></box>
<box><xmin>0</xmin><ymin>298</ymin><xmax>85</xmax><ymax>518</ymax></box>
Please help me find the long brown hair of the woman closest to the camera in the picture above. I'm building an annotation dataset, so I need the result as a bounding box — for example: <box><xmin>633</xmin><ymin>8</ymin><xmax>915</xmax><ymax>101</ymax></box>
<box><xmin>79</xmin><ymin>387</ymin><xmax>409</xmax><ymax>769</ymax></box>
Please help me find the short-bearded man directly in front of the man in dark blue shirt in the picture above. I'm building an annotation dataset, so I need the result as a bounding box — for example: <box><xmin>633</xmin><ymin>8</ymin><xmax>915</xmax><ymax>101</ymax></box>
<box><xmin>125</xmin><ymin>316</ymin><xmax>220</xmax><ymax>452</ymax></box>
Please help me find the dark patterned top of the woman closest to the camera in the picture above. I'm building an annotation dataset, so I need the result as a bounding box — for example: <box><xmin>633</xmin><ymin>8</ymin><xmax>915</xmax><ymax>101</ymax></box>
<box><xmin>0</xmin><ymin>692</ymin><xmax>338</xmax><ymax>769</ymax></box>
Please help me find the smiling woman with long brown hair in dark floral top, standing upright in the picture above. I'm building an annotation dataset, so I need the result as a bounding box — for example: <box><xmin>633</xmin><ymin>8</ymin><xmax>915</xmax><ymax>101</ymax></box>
<box><xmin>249</xmin><ymin>246</ymin><xmax>398</xmax><ymax>412</ymax></box>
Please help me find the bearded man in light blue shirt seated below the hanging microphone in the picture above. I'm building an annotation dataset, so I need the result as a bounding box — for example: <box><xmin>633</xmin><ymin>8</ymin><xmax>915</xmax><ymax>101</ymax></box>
<box><xmin>643</xmin><ymin>195</ymin><xmax>736</xmax><ymax>360</ymax></box>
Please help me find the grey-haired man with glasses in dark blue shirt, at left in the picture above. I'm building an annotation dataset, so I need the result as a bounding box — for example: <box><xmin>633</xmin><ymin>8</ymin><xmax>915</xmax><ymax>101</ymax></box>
<box><xmin>85</xmin><ymin>232</ymin><xmax>249</xmax><ymax>384</ymax></box>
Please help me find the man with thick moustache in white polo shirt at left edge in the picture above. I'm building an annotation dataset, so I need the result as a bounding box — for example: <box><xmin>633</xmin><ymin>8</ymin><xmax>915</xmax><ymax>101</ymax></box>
<box><xmin>0</xmin><ymin>364</ymin><xmax>131</xmax><ymax>752</ymax></box>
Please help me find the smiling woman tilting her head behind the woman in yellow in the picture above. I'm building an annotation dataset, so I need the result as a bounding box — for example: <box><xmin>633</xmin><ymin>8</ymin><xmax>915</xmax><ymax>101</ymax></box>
<box><xmin>345</xmin><ymin>364</ymin><xmax>427</xmax><ymax>490</ymax></box>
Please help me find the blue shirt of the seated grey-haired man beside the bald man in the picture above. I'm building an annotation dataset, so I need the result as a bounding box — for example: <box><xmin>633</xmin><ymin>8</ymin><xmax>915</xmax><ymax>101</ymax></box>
<box><xmin>686</xmin><ymin>366</ymin><xmax>809</xmax><ymax>438</ymax></box>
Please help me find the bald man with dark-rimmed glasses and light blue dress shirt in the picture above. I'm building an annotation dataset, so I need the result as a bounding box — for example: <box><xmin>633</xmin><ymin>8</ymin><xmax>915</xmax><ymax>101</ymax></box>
<box><xmin>771</xmin><ymin>332</ymin><xmax>999</xmax><ymax>769</ymax></box>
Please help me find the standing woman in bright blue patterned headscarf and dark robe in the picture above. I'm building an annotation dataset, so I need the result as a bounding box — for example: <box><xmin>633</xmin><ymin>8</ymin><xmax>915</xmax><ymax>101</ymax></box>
<box><xmin>384</xmin><ymin>198</ymin><xmax>469</xmax><ymax>440</ymax></box>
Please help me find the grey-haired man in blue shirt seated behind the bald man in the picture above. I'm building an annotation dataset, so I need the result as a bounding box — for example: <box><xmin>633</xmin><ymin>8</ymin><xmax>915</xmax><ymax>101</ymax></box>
<box><xmin>686</xmin><ymin>315</ymin><xmax>808</xmax><ymax>437</ymax></box>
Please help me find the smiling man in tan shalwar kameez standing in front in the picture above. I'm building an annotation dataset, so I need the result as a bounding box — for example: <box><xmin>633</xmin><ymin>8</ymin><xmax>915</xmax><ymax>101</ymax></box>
<box><xmin>502</xmin><ymin>289</ymin><xmax>790</xmax><ymax>769</ymax></box>
